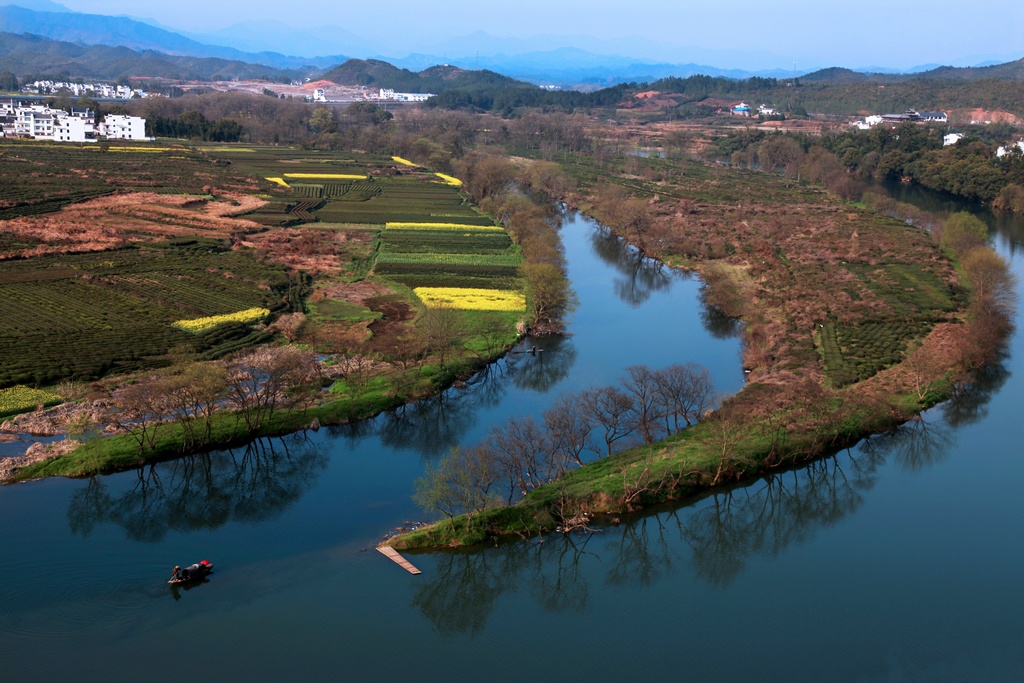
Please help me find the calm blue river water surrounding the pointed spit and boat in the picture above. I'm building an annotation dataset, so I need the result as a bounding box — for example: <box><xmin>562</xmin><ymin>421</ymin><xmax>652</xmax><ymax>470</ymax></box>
<box><xmin>0</xmin><ymin>204</ymin><xmax>1024</xmax><ymax>681</ymax></box>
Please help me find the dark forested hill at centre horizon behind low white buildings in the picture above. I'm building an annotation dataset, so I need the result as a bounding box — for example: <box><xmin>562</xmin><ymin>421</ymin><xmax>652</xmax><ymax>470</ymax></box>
<box><xmin>321</xmin><ymin>59</ymin><xmax>536</xmax><ymax>92</ymax></box>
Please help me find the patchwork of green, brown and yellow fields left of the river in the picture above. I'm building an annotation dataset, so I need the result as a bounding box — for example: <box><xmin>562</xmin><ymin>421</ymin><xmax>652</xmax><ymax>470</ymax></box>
<box><xmin>0</xmin><ymin>143</ymin><xmax>522</xmax><ymax>405</ymax></box>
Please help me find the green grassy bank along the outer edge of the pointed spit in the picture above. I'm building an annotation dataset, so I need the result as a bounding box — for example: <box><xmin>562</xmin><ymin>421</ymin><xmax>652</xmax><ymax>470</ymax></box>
<box><xmin>385</xmin><ymin>382</ymin><xmax>952</xmax><ymax>549</ymax></box>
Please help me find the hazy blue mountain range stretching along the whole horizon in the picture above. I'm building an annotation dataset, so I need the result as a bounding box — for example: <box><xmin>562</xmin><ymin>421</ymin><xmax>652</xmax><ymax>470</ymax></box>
<box><xmin>0</xmin><ymin>0</ymin><xmax>1024</xmax><ymax>92</ymax></box>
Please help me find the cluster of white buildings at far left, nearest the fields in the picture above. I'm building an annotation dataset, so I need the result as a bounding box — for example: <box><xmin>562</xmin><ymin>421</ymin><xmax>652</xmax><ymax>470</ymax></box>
<box><xmin>0</xmin><ymin>100</ymin><xmax>148</xmax><ymax>142</ymax></box>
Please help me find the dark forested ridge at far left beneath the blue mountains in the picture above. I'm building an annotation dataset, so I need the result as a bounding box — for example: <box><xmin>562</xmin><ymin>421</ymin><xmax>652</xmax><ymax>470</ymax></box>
<box><xmin>0</xmin><ymin>33</ymin><xmax>297</xmax><ymax>81</ymax></box>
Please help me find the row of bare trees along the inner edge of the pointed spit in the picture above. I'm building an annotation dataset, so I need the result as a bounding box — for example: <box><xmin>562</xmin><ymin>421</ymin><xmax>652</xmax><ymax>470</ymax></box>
<box><xmin>415</xmin><ymin>362</ymin><xmax>716</xmax><ymax>518</ymax></box>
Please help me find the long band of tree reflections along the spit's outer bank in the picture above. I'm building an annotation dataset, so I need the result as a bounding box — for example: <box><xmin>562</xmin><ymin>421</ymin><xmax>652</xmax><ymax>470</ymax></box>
<box><xmin>413</xmin><ymin>420</ymin><xmax>952</xmax><ymax>635</ymax></box>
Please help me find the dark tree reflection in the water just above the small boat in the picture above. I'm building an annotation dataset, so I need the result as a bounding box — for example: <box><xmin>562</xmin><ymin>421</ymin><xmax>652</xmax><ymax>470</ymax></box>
<box><xmin>68</xmin><ymin>433</ymin><xmax>328</xmax><ymax>542</ymax></box>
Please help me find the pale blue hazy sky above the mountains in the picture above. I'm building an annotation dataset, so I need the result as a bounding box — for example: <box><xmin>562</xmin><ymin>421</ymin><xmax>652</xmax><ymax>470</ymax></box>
<box><xmin>56</xmin><ymin>0</ymin><xmax>1024</xmax><ymax>69</ymax></box>
